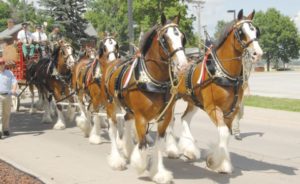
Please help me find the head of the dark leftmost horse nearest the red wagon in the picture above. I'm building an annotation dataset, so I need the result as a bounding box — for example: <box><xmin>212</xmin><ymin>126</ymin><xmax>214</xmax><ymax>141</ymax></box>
<box><xmin>58</xmin><ymin>40</ymin><xmax>76</xmax><ymax>69</ymax></box>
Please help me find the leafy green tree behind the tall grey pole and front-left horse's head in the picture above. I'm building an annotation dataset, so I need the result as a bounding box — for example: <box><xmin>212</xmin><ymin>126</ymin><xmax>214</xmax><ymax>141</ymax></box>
<box><xmin>86</xmin><ymin>0</ymin><xmax>196</xmax><ymax>46</ymax></box>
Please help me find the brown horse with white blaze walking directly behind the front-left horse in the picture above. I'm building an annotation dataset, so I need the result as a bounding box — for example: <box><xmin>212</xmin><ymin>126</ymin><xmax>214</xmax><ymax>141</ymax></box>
<box><xmin>72</xmin><ymin>33</ymin><xmax>119</xmax><ymax>144</ymax></box>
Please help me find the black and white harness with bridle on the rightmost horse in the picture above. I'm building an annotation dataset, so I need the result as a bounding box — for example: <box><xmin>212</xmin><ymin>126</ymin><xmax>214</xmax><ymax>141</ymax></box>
<box><xmin>185</xmin><ymin>20</ymin><xmax>257</xmax><ymax>118</ymax></box>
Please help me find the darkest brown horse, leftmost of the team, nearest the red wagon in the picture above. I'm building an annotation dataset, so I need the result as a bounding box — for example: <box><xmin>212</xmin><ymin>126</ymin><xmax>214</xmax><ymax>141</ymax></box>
<box><xmin>35</xmin><ymin>40</ymin><xmax>75</xmax><ymax>129</ymax></box>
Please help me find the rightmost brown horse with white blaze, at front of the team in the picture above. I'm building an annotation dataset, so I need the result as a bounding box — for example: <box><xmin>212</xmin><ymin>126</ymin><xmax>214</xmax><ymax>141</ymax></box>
<box><xmin>169</xmin><ymin>10</ymin><xmax>263</xmax><ymax>173</ymax></box>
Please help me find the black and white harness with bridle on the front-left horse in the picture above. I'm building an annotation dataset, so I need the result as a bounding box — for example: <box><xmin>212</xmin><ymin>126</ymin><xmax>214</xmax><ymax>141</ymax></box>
<box><xmin>106</xmin><ymin>23</ymin><xmax>184</xmax><ymax>122</ymax></box>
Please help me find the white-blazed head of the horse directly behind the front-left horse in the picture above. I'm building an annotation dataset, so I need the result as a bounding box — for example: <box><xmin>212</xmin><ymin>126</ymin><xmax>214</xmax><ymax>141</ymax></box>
<box><xmin>98</xmin><ymin>33</ymin><xmax>119</xmax><ymax>62</ymax></box>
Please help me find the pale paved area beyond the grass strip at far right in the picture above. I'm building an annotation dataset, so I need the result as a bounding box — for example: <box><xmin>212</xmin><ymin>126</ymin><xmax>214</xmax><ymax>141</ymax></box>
<box><xmin>249</xmin><ymin>71</ymin><xmax>300</xmax><ymax>99</ymax></box>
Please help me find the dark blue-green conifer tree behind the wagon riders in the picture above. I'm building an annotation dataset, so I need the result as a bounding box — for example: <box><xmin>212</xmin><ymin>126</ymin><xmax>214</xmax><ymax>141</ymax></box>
<box><xmin>40</xmin><ymin>0</ymin><xmax>88</xmax><ymax>49</ymax></box>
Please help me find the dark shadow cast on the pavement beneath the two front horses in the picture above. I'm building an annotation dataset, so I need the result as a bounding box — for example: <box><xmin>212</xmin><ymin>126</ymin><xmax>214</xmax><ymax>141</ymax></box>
<box><xmin>139</xmin><ymin>150</ymin><xmax>298</xmax><ymax>183</ymax></box>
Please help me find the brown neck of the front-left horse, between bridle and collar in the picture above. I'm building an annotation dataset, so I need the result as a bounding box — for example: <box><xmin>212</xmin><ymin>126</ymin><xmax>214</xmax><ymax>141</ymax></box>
<box><xmin>145</xmin><ymin>40</ymin><xmax>170</xmax><ymax>81</ymax></box>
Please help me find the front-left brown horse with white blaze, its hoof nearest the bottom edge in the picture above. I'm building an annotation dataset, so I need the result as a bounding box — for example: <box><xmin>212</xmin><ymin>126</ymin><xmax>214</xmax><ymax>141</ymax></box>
<box><xmin>105</xmin><ymin>15</ymin><xmax>187</xmax><ymax>183</ymax></box>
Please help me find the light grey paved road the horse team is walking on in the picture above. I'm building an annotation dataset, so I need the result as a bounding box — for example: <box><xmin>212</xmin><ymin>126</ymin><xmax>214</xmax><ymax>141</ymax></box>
<box><xmin>0</xmin><ymin>103</ymin><xmax>300</xmax><ymax>184</ymax></box>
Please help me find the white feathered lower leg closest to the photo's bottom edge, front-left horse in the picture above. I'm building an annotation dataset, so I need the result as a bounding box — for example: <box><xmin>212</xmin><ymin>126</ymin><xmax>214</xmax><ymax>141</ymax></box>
<box><xmin>150</xmin><ymin>138</ymin><xmax>173</xmax><ymax>184</ymax></box>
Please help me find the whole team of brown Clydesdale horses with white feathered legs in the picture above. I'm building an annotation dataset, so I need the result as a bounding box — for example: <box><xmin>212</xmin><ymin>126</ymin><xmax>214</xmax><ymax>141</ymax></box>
<box><xmin>24</xmin><ymin>10</ymin><xmax>262</xmax><ymax>183</ymax></box>
